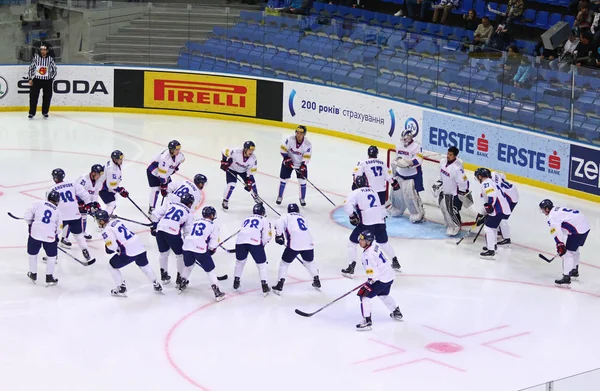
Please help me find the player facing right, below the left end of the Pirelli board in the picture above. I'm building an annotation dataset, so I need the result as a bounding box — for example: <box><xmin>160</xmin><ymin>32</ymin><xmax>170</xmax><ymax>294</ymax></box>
<box><xmin>146</xmin><ymin>140</ymin><xmax>185</xmax><ymax>214</ymax></box>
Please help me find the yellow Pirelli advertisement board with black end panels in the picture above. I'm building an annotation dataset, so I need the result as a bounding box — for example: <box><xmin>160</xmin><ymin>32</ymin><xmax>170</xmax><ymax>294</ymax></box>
<box><xmin>114</xmin><ymin>69</ymin><xmax>283</xmax><ymax>121</ymax></box>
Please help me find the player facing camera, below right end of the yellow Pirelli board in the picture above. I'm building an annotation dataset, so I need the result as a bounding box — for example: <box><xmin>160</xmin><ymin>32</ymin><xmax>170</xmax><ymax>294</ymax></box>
<box><xmin>221</xmin><ymin>141</ymin><xmax>262</xmax><ymax>210</ymax></box>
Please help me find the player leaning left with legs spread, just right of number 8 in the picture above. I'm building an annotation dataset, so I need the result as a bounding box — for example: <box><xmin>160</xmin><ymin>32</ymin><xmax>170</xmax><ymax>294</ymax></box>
<box><xmin>96</xmin><ymin>210</ymin><xmax>162</xmax><ymax>297</ymax></box>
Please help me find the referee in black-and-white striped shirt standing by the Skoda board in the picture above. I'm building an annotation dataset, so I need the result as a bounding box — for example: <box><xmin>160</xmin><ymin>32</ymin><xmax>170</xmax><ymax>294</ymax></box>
<box><xmin>29</xmin><ymin>43</ymin><xmax>56</xmax><ymax>119</ymax></box>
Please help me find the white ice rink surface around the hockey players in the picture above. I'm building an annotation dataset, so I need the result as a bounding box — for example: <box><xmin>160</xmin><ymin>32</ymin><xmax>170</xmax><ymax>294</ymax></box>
<box><xmin>0</xmin><ymin>113</ymin><xmax>600</xmax><ymax>391</ymax></box>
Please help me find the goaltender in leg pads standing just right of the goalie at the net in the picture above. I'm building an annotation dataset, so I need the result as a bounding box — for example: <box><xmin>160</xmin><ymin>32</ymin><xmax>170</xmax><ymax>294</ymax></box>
<box><xmin>432</xmin><ymin>147</ymin><xmax>473</xmax><ymax>236</ymax></box>
